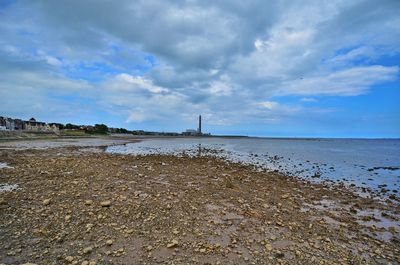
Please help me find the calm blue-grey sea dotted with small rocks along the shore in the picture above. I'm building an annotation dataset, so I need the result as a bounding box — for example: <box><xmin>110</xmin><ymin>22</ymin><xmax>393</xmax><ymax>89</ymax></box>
<box><xmin>106</xmin><ymin>137</ymin><xmax>400</xmax><ymax>196</ymax></box>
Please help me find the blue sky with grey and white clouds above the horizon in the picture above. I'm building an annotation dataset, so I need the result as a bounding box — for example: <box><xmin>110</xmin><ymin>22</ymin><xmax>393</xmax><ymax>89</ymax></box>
<box><xmin>0</xmin><ymin>0</ymin><xmax>400</xmax><ymax>137</ymax></box>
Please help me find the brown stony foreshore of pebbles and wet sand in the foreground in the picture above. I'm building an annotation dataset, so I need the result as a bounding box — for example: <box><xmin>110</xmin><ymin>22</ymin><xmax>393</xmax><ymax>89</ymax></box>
<box><xmin>0</xmin><ymin>143</ymin><xmax>400</xmax><ymax>265</ymax></box>
